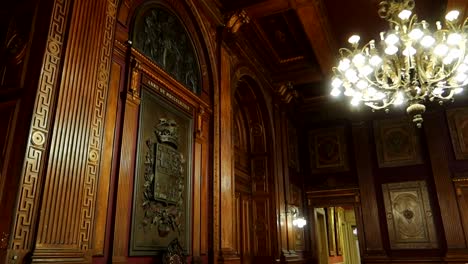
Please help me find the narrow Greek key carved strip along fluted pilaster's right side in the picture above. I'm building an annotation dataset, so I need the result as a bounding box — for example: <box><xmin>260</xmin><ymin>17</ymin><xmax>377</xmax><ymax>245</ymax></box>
<box><xmin>80</xmin><ymin>0</ymin><xmax>117</xmax><ymax>250</ymax></box>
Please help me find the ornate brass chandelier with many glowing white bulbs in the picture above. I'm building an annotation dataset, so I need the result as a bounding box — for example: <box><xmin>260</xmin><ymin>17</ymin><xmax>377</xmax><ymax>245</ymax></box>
<box><xmin>331</xmin><ymin>0</ymin><xmax>468</xmax><ymax>127</ymax></box>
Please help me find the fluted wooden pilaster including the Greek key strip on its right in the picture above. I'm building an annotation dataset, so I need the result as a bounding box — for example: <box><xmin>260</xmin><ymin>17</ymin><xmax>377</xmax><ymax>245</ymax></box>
<box><xmin>30</xmin><ymin>0</ymin><xmax>116</xmax><ymax>259</ymax></box>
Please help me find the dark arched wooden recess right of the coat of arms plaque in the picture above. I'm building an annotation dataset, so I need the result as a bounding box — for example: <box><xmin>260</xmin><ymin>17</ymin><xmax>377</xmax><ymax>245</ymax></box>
<box><xmin>233</xmin><ymin>75</ymin><xmax>276</xmax><ymax>263</ymax></box>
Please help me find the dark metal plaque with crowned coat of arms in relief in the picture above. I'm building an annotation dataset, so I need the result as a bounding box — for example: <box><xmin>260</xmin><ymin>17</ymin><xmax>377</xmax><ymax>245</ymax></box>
<box><xmin>130</xmin><ymin>85</ymin><xmax>192</xmax><ymax>255</ymax></box>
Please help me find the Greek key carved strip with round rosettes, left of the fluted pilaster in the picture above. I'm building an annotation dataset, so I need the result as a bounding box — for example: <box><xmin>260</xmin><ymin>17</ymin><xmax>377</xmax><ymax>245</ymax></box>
<box><xmin>11</xmin><ymin>0</ymin><xmax>70</xmax><ymax>253</ymax></box>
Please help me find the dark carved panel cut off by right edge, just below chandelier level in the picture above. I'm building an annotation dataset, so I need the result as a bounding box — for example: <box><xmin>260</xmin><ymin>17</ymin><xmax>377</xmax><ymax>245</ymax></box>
<box><xmin>447</xmin><ymin>108</ymin><xmax>468</xmax><ymax>160</ymax></box>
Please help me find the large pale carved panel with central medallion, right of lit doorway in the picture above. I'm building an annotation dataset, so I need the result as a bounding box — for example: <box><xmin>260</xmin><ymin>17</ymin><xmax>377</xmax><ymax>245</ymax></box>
<box><xmin>382</xmin><ymin>181</ymin><xmax>438</xmax><ymax>249</ymax></box>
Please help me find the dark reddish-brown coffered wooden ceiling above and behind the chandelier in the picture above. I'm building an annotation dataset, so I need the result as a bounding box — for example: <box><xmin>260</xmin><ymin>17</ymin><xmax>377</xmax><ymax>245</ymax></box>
<box><xmin>219</xmin><ymin>0</ymin><xmax>468</xmax><ymax>105</ymax></box>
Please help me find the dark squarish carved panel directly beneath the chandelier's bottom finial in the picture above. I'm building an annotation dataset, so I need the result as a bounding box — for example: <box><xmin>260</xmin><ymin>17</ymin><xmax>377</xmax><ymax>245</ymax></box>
<box><xmin>374</xmin><ymin>118</ymin><xmax>423</xmax><ymax>167</ymax></box>
